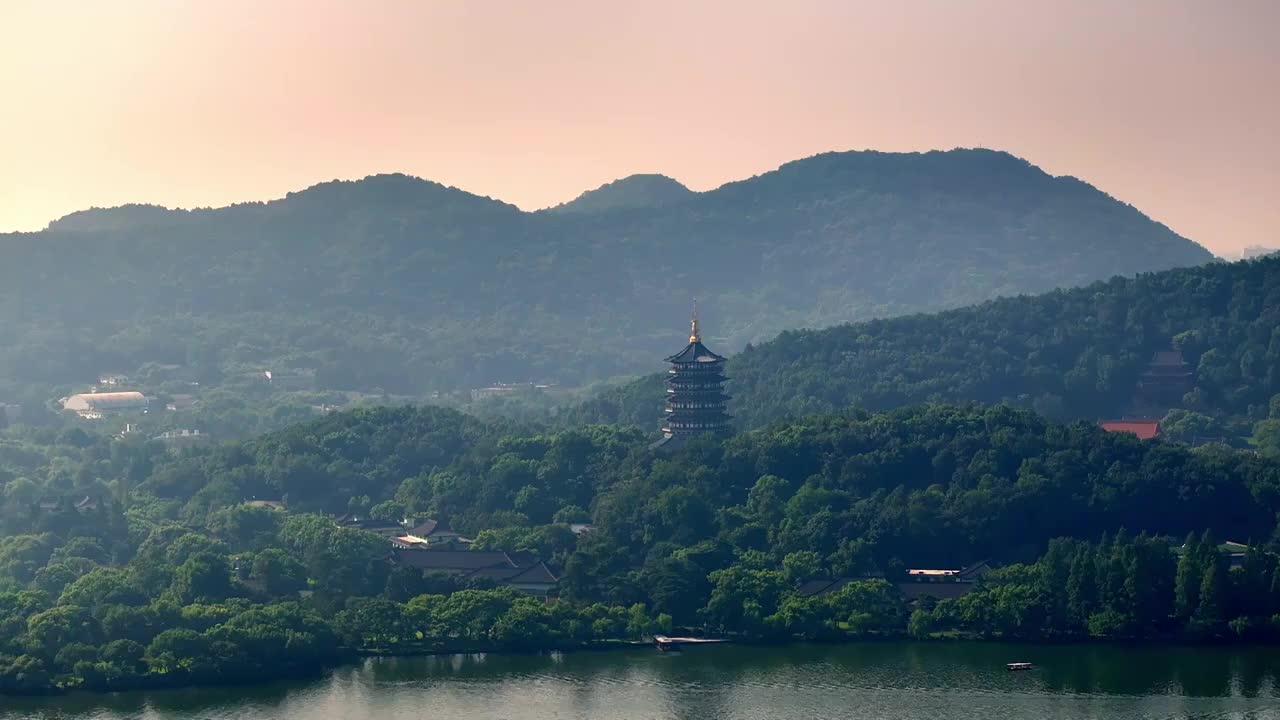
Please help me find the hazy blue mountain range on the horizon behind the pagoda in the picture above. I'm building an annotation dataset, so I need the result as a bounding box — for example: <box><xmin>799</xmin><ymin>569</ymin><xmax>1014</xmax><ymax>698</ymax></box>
<box><xmin>0</xmin><ymin>150</ymin><xmax>1211</xmax><ymax>400</ymax></box>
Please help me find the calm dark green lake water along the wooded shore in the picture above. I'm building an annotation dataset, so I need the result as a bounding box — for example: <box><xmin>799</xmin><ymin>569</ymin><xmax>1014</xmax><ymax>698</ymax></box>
<box><xmin>0</xmin><ymin>643</ymin><xmax>1280</xmax><ymax>720</ymax></box>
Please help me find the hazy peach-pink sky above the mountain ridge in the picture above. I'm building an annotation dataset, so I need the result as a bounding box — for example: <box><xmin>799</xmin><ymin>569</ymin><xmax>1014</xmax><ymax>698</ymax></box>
<box><xmin>0</xmin><ymin>0</ymin><xmax>1280</xmax><ymax>254</ymax></box>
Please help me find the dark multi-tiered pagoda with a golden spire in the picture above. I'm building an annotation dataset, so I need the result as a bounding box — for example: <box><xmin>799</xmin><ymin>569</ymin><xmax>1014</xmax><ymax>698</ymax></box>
<box><xmin>657</xmin><ymin>307</ymin><xmax>730</xmax><ymax>448</ymax></box>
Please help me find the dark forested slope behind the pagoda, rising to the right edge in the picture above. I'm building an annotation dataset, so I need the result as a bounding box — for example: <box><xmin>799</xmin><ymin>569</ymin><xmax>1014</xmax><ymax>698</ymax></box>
<box><xmin>562</xmin><ymin>258</ymin><xmax>1280</xmax><ymax>439</ymax></box>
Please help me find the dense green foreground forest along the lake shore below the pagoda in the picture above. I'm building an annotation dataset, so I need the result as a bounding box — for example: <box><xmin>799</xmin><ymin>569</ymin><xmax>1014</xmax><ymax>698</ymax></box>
<box><xmin>0</xmin><ymin>405</ymin><xmax>1280</xmax><ymax>692</ymax></box>
